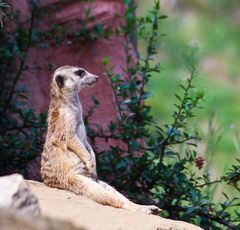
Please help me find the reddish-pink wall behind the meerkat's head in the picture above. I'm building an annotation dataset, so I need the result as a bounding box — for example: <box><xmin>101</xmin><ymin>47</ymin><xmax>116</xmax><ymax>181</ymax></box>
<box><xmin>9</xmin><ymin>0</ymin><xmax>133</xmax><ymax>178</ymax></box>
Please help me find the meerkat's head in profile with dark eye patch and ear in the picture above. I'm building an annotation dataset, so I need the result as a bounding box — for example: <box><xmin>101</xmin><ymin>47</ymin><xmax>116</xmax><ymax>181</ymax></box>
<box><xmin>52</xmin><ymin>66</ymin><xmax>98</xmax><ymax>93</ymax></box>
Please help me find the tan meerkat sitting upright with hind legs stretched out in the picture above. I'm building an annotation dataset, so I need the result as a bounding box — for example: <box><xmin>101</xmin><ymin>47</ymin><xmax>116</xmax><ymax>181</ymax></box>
<box><xmin>41</xmin><ymin>66</ymin><xmax>160</xmax><ymax>214</ymax></box>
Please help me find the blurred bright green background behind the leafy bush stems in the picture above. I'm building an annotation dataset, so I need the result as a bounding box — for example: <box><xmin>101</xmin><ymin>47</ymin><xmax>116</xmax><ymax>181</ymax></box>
<box><xmin>136</xmin><ymin>0</ymin><xmax>240</xmax><ymax>194</ymax></box>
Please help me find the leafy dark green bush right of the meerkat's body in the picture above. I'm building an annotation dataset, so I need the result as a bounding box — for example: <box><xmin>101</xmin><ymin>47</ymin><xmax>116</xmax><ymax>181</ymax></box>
<box><xmin>88</xmin><ymin>1</ymin><xmax>240</xmax><ymax>229</ymax></box>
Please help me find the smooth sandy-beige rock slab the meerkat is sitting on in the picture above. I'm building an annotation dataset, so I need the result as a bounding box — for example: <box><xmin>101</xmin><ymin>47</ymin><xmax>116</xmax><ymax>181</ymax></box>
<box><xmin>27</xmin><ymin>181</ymin><xmax>201</xmax><ymax>230</ymax></box>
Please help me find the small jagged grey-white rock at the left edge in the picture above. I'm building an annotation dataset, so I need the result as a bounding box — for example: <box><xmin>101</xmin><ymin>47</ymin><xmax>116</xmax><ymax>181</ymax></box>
<box><xmin>0</xmin><ymin>174</ymin><xmax>40</xmax><ymax>215</ymax></box>
